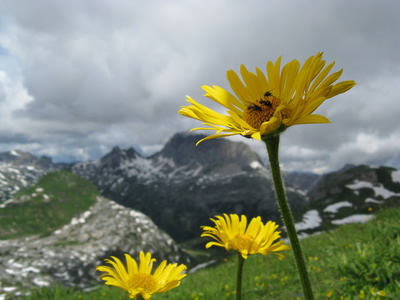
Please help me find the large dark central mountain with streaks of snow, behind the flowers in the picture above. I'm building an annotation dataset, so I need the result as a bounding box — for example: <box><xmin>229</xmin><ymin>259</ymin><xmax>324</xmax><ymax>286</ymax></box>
<box><xmin>71</xmin><ymin>133</ymin><xmax>306</xmax><ymax>242</ymax></box>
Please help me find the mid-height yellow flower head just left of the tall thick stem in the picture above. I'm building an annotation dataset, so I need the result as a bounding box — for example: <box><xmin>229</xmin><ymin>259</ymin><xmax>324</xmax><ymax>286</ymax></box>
<box><xmin>201</xmin><ymin>214</ymin><xmax>290</xmax><ymax>259</ymax></box>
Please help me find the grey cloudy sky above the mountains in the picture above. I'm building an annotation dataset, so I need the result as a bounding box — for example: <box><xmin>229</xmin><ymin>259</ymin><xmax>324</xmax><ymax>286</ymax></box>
<box><xmin>0</xmin><ymin>0</ymin><xmax>400</xmax><ymax>172</ymax></box>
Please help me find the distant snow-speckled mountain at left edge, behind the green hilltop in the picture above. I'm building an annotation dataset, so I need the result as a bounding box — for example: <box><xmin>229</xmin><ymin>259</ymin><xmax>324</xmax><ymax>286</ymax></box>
<box><xmin>0</xmin><ymin>150</ymin><xmax>63</xmax><ymax>204</ymax></box>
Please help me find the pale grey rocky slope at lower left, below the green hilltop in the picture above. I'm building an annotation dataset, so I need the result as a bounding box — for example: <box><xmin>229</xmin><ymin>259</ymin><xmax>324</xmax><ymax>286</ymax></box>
<box><xmin>0</xmin><ymin>197</ymin><xmax>190</xmax><ymax>299</ymax></box>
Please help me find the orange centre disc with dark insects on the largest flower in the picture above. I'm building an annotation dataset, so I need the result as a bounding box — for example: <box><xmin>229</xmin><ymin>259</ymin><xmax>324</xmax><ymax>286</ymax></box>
<box><xmin>243</xmin><ymin>92</ymin><xmax>281</xmax><ymax>129</ymax></box>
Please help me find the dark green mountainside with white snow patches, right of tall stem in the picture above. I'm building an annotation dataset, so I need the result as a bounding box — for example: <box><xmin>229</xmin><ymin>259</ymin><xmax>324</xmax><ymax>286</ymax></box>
<box><xmin>290</xmin><ymin>165</ymin><xmax>400</xmax><ymax>235</ymax></box>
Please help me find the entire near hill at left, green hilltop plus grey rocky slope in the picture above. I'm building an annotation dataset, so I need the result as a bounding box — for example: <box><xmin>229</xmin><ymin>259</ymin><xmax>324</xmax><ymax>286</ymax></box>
<box><xmin>0</xmin><ymin>171</ymin><xmax>191</xmax><ymax>299</ymax></box>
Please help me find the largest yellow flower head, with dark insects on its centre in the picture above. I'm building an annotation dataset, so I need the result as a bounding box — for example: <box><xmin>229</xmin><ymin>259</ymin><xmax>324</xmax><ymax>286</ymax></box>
<box><xmin>179</xmin><ymin>53</ymin><xmax>356</xmax><ymax>143</ymax></box>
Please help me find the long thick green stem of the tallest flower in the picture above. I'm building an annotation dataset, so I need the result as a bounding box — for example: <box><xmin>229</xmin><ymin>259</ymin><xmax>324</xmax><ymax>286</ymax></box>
<box><xmin>264</xmin><ymin>134</ymin><xmax>314</xmax><ymax>300</ymax></box>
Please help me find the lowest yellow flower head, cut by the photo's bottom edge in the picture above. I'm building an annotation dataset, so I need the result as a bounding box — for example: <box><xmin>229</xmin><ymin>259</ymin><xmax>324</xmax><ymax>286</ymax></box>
<box><xmin>96</xmin><ymin>252</ymin><xmax>186</xmax><ymax>299</ymax></box>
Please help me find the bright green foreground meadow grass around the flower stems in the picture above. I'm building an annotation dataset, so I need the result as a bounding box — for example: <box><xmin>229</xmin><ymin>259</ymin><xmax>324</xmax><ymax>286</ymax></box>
<box><xmin>25</xmin><ymin>208</ymin><xmax>400</xmax><ymax>300</ymax></box>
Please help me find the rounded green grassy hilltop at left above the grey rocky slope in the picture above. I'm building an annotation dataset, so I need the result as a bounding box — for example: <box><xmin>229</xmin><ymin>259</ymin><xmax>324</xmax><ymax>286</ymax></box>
<box><xmin>0</xmin><ymin>171</ymin><xmax>99</xmax><ymax>239</ymax></box>
